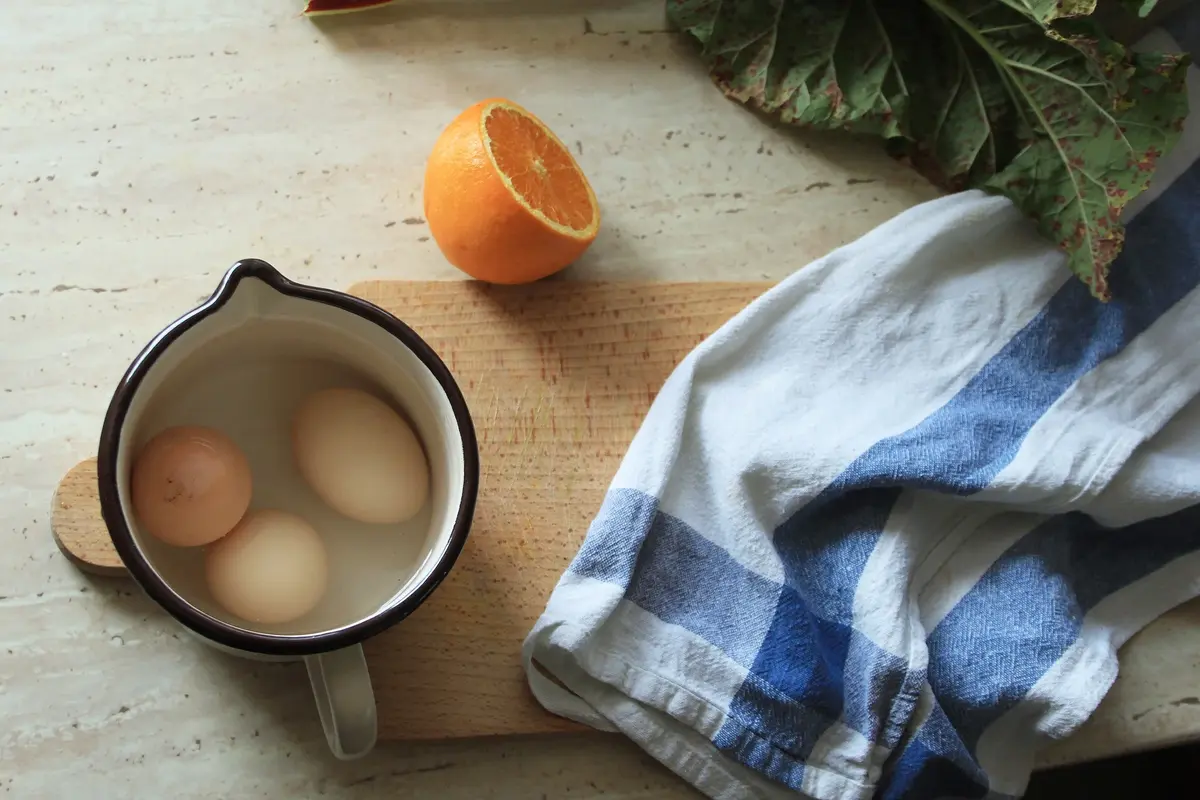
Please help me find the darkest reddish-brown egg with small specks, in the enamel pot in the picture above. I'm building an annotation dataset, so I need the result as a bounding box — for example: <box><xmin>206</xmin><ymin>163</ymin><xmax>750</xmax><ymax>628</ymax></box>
<box><xmin>131</xmin><ymin>426</ymin><xmax>253</xmax><ymax>547</ymax></box>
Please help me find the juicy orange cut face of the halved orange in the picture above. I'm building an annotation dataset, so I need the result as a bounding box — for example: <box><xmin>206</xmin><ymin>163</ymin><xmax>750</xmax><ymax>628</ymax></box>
<box><xmin>484</xmin><ymin>107</ymin><xmax>595</xmax><ymax>231</ymax></box>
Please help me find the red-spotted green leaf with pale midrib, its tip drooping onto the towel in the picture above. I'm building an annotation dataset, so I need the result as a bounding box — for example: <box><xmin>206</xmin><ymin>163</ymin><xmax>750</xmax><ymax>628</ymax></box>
<box><xmin>926</xmin><ymin>0</ymin><xmax>1187</xmax><ymax>300</ymax></box>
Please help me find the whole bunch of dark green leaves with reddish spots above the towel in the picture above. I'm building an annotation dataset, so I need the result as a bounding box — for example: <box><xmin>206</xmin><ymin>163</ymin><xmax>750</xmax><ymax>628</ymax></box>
<box><xmin>667</xmin><ymin>0</ymin><xmax>1189</xmax><ymax>300</ymax></box>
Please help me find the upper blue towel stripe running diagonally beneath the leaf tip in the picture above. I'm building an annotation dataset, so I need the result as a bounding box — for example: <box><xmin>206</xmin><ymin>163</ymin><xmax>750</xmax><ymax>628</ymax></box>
<box><xmin>818</xmin><ymin>162</ymin><xmax>1200</xmax><ymax>501</ymax></box>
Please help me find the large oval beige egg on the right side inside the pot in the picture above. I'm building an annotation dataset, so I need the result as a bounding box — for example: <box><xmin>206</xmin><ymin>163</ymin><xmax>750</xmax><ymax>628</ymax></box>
<box><xmin>292</xmin><ymin>389</ymin><xmax>430</xmax><ymax>523</ymax></box>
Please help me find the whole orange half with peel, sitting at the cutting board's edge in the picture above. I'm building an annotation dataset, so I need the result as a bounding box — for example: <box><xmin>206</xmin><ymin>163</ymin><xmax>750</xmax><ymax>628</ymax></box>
<box><xmin>425</xmin><ymin>98</ymin><xmax>600</xmax><ymax>283</ymax></box>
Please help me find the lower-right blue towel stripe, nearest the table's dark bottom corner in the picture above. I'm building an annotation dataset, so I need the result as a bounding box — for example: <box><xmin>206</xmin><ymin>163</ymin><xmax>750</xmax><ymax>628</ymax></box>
<box><xmin>882</xmin><ymin>506</ymin><xmax>1200</xmax><ymax>800</ymax></box>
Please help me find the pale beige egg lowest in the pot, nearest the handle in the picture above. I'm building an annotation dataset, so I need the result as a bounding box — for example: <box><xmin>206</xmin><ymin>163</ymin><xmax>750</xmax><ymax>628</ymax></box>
<box><xmin>204</xmin><ymin>509</ymin><xmax>329</xmax><ymax>624</ymax></box>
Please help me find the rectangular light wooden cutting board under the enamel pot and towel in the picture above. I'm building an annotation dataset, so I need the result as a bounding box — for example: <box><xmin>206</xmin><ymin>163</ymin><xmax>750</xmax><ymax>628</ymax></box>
<box><xmin>52</xmin><ymin>282</ymin><xmax>769</xmax><ymax>739</ymax></box>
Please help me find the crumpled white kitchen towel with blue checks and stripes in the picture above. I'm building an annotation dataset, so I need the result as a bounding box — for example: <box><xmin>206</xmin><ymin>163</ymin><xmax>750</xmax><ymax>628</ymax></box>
<box><xmin>524</xmin><ymin>15</ymin><xmax>1200</xmax><ymax>800</ymax></box>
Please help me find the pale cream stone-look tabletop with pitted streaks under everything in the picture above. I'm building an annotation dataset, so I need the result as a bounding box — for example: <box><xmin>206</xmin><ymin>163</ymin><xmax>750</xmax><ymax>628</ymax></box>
<box><xmin>0</xmin><ymin>0</ymin><xmax>1200</xmax><ymax>800</ymax></box>
